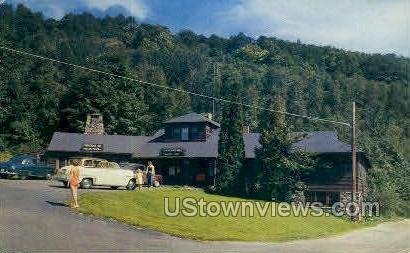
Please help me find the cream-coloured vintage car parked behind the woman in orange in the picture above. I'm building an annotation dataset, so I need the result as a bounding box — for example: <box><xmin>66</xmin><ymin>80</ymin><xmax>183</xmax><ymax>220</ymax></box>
<box><xmin>54</xmin><ymin>157</ymin><xmax>136</xmax><ymax>190</ymax></box>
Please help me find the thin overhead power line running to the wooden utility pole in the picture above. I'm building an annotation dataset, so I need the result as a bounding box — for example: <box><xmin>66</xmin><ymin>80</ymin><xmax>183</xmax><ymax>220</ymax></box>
<box><xmin>0</xmin><ymin>46</ymin><xmax>351</xmax><ymax>127</ymax></box>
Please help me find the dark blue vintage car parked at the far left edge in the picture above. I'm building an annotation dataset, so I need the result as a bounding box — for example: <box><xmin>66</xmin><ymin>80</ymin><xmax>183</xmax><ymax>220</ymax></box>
<box><xmin>0</xmin><ymin>155</ymin><xmax>54</xmax><ymax>179</ymax></box>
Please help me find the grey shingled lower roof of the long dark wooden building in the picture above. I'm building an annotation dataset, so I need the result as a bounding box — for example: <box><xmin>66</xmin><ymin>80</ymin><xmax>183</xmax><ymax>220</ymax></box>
<box><xmin>48</xmin><ymin>130</ymin><xmax>351</xmax><ymax>158</ymax></box>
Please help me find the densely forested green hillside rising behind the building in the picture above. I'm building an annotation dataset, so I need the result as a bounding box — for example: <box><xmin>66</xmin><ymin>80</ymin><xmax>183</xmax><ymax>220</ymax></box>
<box><xmin>0</xmin><ymin>5</ymin><xmax>410</xmax><ymax>213</ymax></box>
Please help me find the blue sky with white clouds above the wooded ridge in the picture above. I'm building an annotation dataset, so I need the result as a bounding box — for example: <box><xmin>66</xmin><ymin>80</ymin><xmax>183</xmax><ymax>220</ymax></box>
<box><xmin>0</xmin><ymin>0</ymin><xmax>410</xmax><ymax>57</ymax></box>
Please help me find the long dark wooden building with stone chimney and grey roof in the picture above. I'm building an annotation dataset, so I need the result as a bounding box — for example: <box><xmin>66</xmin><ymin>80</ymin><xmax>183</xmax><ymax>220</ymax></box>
<box><xmin>45</xmin><ymin>113</ymin><xmax>370</xmax><ymax>204</ymax></box>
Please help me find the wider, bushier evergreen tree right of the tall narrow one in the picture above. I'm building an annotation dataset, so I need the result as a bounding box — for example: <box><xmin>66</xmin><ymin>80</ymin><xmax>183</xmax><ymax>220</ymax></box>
<box><xmin>254</xmin><ymin>97</ymin><xmax>312</xmax><ymax>201</ymax></box>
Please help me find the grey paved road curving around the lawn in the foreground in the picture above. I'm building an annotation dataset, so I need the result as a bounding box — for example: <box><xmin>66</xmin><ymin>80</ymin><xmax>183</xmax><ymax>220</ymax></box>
<box><xmin>0</xmin><ymin>180</ymin><xmax>410</xmax><ymax>253</ymax></box>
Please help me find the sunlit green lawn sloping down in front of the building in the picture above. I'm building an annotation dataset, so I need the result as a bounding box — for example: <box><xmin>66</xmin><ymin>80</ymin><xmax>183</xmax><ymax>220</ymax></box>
<box><xmin>79</xmin><ymin>187</ymin><xmax>374</xmax><ymax>242</ymax></box>
